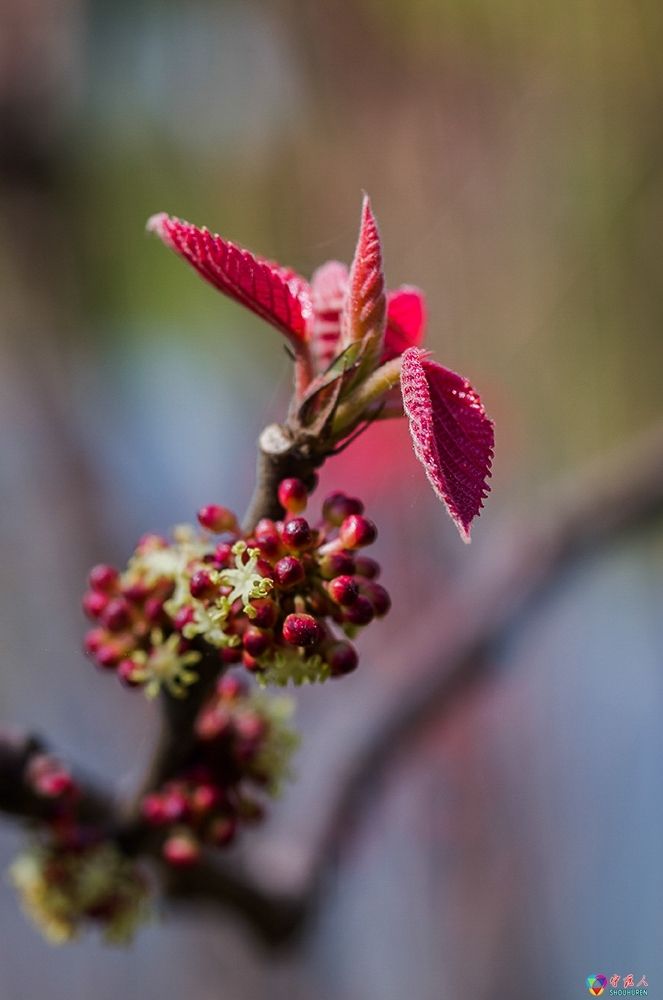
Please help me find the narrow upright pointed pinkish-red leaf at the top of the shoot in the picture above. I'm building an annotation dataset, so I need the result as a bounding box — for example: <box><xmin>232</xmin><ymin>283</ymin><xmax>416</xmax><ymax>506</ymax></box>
<box><xmin>341</xmin><ymin>196</ymin><xmax>387</xmax><ymax>357</ymax></box>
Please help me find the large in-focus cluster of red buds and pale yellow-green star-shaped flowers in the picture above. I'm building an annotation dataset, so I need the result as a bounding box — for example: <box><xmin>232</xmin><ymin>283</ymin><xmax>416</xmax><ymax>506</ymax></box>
<box><xmin>83</xmin><ymin>479</ymin><xmax>391</xmax><ymax>697</ymax></box>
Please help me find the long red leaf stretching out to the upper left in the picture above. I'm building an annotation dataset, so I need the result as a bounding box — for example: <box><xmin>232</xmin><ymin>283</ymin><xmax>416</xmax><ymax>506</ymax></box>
<box><xmin>147</xmin><ymin>212</ymin><xmax>312</xmax><ymax>342</ymax></box>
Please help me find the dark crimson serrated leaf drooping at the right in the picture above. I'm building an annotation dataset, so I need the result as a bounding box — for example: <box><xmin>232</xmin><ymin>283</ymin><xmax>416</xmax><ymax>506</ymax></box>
<box><xmin>401</xmin><ymin>347</ymin><xmax>494</xmax><ymax>542</ymax></box>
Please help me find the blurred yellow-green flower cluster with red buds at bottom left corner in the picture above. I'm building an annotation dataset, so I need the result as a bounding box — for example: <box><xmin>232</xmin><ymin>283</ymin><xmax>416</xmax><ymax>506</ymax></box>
<box><xmin>9</xmin><ymin>753</ymin><xmax>151</xmax><ymax>944</ymax></box>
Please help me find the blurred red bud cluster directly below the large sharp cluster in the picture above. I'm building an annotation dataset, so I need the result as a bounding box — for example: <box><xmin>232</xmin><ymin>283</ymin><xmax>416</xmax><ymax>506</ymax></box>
<box><xmin>142</xmin><ymin>674</ymin><xmax>299</xmax><ymax>865</ymax></box>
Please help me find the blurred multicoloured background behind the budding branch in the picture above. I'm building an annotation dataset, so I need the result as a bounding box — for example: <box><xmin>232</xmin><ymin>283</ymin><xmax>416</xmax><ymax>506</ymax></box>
<box><xmin>0</xmin><ymin>0</ymin><xmax>663</xmax><ymax>1000</ymax></box>
